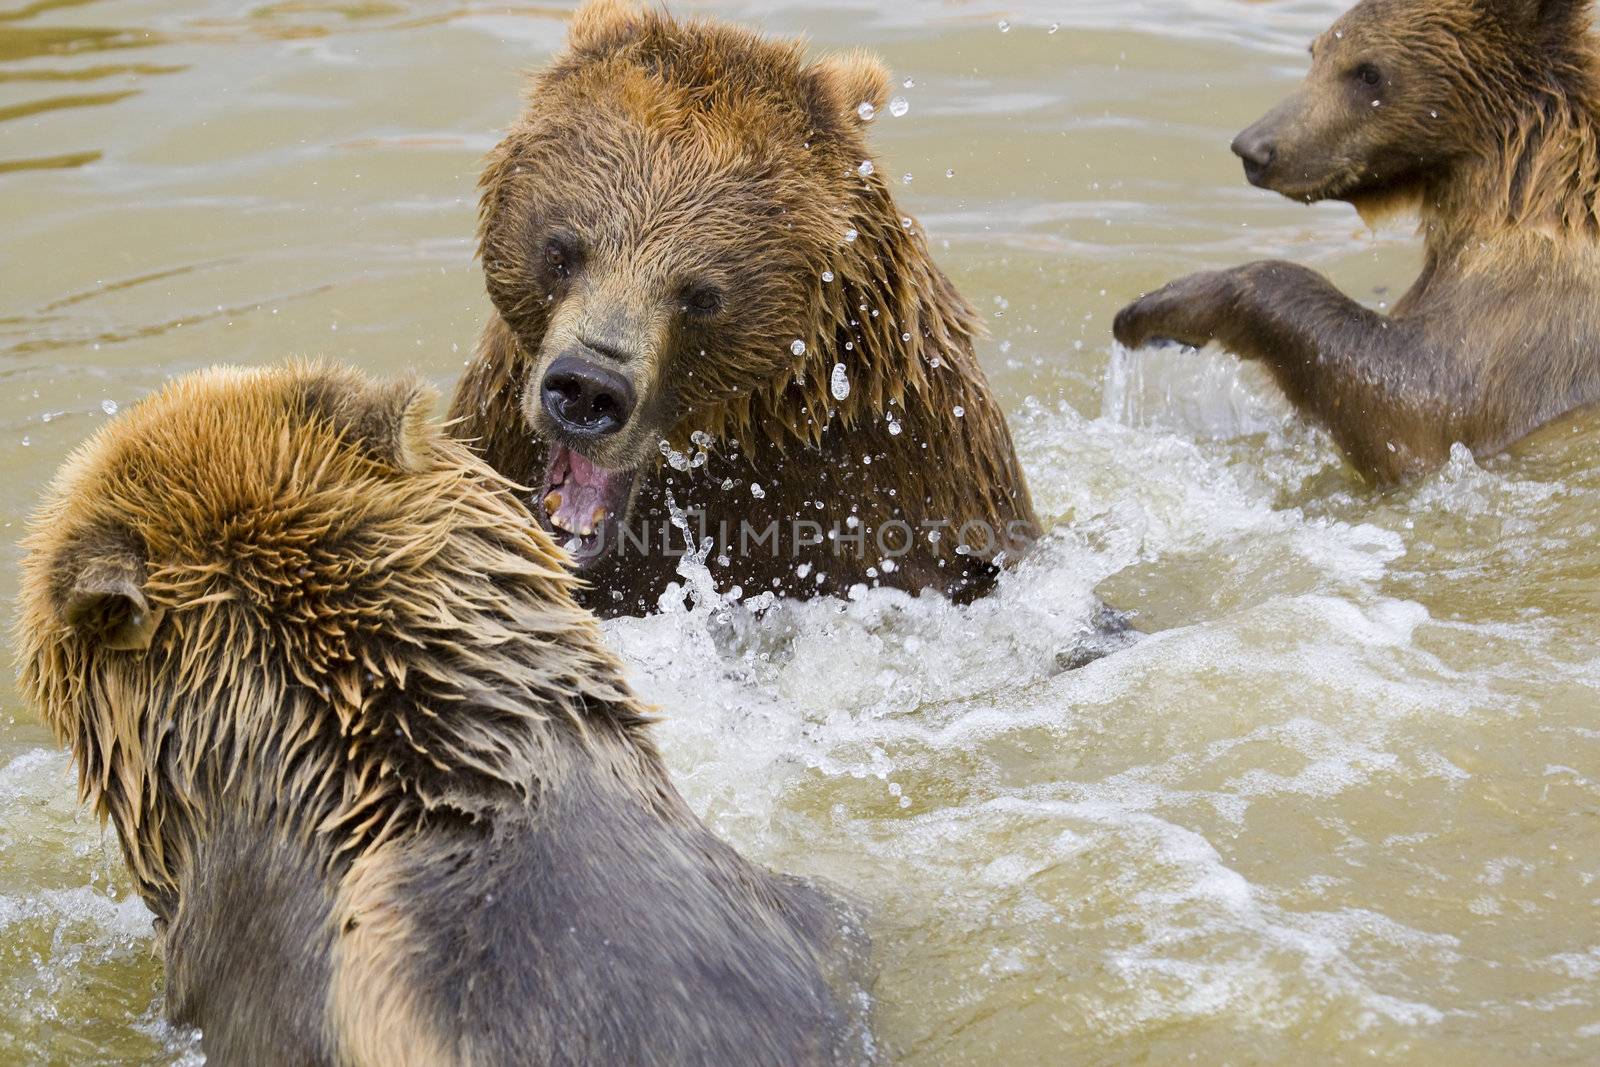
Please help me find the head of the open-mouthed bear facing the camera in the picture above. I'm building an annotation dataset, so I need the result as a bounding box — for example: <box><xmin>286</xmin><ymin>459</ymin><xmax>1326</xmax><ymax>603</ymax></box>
<box><xmin>480</xmin><ymin>0</ymin><xmax>910</xmax><ymax>566</ymax></box>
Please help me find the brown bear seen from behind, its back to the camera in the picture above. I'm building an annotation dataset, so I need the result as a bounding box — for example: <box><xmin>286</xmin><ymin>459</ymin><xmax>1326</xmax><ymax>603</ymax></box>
<box><xmin>18</xmin><ymin>366</ymin><xmax>870</xmax><ymax>1067</ymax></box>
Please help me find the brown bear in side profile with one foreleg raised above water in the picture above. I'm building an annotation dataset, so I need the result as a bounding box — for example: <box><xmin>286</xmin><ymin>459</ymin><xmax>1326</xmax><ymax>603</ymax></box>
<box><xmin>1115</xmin><ymin>0</ymin><xmax>1600</xmax><ymax>483</ymax></box>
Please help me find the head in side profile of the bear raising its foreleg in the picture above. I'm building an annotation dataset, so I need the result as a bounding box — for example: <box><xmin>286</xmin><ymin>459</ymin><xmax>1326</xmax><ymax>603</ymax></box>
<box><xmin>1234</xmin><ymin>0</ymin><xmax>1589</xmax><ymax>216</ymax></box>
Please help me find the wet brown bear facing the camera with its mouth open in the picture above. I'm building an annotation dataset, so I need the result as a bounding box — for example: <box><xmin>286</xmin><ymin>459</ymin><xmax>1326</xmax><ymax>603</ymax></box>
<box><xmin>451</xmin><ymin>0</ymin><xmax>1037</xmax><ymax>613</ymax></box>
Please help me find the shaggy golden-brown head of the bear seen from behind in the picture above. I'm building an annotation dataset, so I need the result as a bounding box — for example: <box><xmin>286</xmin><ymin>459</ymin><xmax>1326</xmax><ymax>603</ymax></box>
<box><xmin>16</xmin><ymin>365</ymin><xmax>634</xmax><ymax>918</ymax></box>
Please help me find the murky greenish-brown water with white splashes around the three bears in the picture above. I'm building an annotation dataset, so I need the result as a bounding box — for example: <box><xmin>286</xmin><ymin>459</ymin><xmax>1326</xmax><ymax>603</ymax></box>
<box><xmin>0</xmin><ymin>0</ymin><xmax>1600</xmax><ymax>1067</ymax></box>
